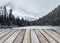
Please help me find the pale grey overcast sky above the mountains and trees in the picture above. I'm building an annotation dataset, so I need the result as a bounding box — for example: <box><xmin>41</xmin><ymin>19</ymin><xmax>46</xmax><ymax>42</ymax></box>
<box><xmin>0</xmin><ymin>0</ymin><xmax>60</xmax><ymax>17</ymax></box>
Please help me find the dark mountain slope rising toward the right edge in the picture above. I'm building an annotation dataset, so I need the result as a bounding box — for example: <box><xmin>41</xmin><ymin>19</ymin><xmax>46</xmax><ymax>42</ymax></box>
<box><xmin>31</xmin><ymin>5</ymin><xmax>60</xmax><ymax>25</ymax></box>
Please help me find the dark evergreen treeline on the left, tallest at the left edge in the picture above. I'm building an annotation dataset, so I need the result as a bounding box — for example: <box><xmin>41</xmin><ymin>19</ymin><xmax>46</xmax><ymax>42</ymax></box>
<box><xmin>0</xmin><ymin>6</ymin><xmax>30</xmax><ymax>26</ymax></box>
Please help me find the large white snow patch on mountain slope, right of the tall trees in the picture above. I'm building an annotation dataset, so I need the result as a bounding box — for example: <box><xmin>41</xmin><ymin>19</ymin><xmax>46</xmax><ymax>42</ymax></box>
<box><xmin>13</xmin><ymin>11</ymin><xmax>37</xmax><ymax>21</ymax></box>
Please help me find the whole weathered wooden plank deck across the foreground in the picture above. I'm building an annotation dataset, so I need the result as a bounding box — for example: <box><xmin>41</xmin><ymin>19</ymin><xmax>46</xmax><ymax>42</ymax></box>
<box><xmin>0</xmin><ymin>29</ymin><xmax>60</xmax><ymax>43</ymax></box>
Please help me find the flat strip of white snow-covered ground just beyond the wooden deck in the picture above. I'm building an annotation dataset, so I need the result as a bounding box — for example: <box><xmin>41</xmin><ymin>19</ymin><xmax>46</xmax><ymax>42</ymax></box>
<box><xmin>13</xmin><ymin>26</ymin><xmax>60</xmax><ymax>29</ymax></box>
